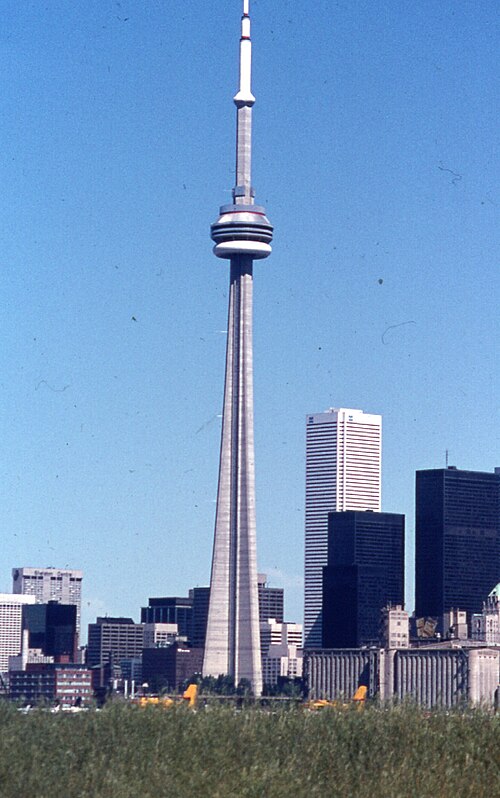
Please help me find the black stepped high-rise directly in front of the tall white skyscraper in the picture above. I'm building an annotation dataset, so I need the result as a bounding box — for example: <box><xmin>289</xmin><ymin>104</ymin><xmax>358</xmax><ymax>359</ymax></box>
<box><xmin>323</xmin><ymin>510</ymin><xmax>405</xmax><ymax>648</ymax></box>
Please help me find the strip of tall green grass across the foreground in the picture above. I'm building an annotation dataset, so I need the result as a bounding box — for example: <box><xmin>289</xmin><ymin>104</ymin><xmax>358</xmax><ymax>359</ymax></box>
<box><xmin>0</xmin><ymin>703</ymin><xmax>500</xmax><ymax>798</ymax></box>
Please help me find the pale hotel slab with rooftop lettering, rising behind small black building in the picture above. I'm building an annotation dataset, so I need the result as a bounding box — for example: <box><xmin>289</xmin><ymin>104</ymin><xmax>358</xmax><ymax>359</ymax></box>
<box><xmin>12</xmin><ymin>568</ymin><xmax>83</xmax><ymax>639</ymax></box>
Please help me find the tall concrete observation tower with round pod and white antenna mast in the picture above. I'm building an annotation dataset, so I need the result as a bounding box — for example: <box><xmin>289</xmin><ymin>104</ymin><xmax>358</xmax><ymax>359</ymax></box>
<box><xmin>203</xmin><ymin>0</ymin><xmax>273</xmax><ymax>695</ymax></box>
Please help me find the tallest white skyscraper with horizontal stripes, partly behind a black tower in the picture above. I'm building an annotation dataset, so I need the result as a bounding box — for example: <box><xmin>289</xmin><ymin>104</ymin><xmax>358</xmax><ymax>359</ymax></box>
<box><xmin>304</xmin><ymin>407</ymin><xmax>382</xmax><ymax>648</ymax></box>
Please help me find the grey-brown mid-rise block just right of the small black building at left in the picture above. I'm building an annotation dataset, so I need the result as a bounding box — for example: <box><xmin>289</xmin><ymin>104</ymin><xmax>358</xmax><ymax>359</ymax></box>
<box><xmin>87</xmin><ymin>617</ymin><xmax>144</xmax><ymax>669</ymax></box>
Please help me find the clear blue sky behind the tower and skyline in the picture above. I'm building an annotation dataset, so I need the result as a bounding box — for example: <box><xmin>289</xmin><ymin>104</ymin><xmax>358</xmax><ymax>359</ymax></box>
<box><xmin>0</xmin><ymin>0</ymin><xmax>500</xmax><ymax>636</ymax></box>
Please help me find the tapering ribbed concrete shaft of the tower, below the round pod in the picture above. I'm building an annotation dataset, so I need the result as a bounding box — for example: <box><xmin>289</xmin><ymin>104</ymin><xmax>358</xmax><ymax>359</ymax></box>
<box><xmin>203</xmin><ymin>256</ymin><xmax>262</xmax><ymax>693</ymax></box>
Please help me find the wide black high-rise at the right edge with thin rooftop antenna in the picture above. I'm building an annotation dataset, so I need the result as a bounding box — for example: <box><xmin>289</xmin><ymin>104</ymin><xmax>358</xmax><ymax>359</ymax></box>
<box><xmin>415</xmin><ymin>466</ymin><xmax>500</xmax><ymax>631</ymax></box>
